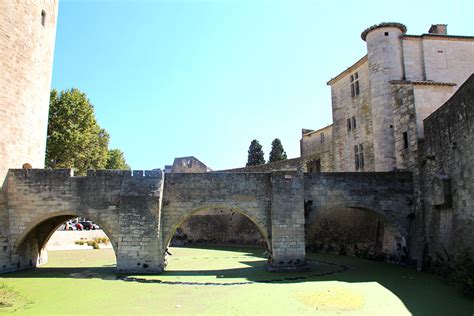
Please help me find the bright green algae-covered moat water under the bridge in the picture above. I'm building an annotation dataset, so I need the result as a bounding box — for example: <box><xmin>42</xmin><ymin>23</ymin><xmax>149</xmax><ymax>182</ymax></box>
<box><xmin>0</xmin><ymin>247</ymin><xmax>474</xmax><ymax>316</ymax></box>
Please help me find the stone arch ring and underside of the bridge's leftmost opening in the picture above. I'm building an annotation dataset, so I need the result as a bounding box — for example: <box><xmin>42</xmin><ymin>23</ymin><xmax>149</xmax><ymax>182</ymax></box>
<box><xmin>13</xmin><ymin>210</ymin><xmax>118</xmax><ymax>269</ymax></box>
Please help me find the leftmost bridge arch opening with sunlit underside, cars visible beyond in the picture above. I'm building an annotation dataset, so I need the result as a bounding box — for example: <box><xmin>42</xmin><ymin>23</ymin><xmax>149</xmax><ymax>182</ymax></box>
<box><xmin>13</xmin><ymin>212</ymin><xmax>117</xmax><ymax>270</ymax></box>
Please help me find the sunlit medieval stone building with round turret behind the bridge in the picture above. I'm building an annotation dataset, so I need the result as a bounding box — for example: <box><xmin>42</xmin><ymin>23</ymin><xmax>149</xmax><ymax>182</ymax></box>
<box><xmin>301</xmin><ymin>23</ymin><xmax>474</xmax><ymax>172</ymax></box>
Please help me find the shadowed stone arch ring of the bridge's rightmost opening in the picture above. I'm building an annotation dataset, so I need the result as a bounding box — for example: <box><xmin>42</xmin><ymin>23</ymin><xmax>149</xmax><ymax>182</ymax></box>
<box><xmin>307</xmin><ymin>202</ymin><xmax>408</xmax><ymax>260</ymax></box>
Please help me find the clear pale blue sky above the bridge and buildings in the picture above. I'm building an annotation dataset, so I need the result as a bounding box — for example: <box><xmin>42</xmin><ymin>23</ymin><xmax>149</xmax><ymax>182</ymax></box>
<box><xmin>52</xmin><ymin>0</ymin><xmax>474</xmax><ymax>170</ymax></box>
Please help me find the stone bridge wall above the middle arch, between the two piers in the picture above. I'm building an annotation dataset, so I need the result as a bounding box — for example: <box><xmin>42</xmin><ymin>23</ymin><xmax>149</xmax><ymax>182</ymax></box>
<box><xmin>161</xmin><ymin>173</ymin><xmax>271</xmax><ymax>247</ymax></box>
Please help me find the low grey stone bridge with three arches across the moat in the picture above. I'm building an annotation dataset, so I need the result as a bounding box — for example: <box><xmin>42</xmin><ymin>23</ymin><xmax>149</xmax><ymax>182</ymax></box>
<box><xmin>0</xmin><ymin>169</ymin><xmax>413</xmax><ymax>274</ymax></box>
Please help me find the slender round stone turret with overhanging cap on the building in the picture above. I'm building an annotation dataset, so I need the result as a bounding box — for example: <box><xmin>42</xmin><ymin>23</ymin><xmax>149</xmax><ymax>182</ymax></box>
<box><xmin>361</xmin><ymin>23</ymin><xmax>407</xmax><ymax>171</ymax></box>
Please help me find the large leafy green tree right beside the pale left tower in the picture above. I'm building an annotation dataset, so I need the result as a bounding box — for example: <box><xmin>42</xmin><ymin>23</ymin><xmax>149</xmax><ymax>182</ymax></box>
<box><xmin>45</xmin><ymin>89</ymin><xmax>109</xmax><ymax>175</ymax></box>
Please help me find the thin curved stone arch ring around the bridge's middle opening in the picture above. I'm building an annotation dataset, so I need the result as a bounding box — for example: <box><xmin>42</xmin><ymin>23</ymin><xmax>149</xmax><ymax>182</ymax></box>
<box><xmin>163</xmin><ymin>204</ymin><xmax>271</xmax><ymax>249</ymax></box>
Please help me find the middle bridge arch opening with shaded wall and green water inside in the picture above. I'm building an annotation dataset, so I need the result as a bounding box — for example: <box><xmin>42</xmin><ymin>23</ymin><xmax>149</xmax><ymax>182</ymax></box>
<box><xmin>163</xmin><ymin>205</ymin><xmax>271</xmax><ymax>271</ymax></box>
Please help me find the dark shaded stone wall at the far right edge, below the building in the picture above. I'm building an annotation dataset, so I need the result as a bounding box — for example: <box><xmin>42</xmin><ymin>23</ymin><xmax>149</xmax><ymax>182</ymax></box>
<box><xmin>418</xmin><ymin>75</ymin><xmax>474</xmax><ymax>260</ymax></box>
